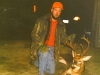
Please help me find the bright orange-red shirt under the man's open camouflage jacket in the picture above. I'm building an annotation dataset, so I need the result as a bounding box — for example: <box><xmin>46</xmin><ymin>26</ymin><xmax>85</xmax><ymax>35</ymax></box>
<box><xmin>45</xmin><ymin>20</ymin><xmax>57</xmax><ymax>46</ymax></box>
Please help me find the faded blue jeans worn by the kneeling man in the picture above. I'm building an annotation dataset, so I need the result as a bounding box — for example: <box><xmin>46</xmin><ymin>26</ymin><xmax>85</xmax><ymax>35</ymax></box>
<box><xmin>35</xmin><ymin>47</ymin><xmax>55</xmax><ymax>75</ymax></box>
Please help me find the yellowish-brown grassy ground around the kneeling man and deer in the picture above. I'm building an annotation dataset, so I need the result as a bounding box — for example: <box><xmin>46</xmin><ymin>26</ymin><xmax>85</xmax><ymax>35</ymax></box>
<box><xmin>0</xmin><ymin>40</ymin><xmax>100</xmax><ymax>75</ymax></box>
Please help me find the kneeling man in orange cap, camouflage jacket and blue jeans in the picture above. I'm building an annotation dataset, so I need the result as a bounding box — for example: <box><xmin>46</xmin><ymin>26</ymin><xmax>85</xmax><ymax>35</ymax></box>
<box><xmin>31</xmin><ymin>2</ymin><xmax>67</xmax><ymax>75</ymax></box>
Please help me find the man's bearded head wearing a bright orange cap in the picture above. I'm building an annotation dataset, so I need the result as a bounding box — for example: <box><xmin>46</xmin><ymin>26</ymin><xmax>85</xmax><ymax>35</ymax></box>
<box><xmin>51</xmin><ymin>2</ymin><xmax>63</xmax><ymax>19</ymax></box>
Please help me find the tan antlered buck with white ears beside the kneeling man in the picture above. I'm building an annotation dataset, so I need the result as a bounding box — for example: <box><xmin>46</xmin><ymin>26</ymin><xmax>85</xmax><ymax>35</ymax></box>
<box><xmin>59</xmin><ymin>38</ymin><xmax>92</xmax><ymax>75</ymax></box>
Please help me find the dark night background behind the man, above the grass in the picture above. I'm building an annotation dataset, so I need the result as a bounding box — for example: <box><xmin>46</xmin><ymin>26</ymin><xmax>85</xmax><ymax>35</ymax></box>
<box><xmin>0</xmin><ymin>0</ymin><xmax>94</xmax><ymax>40</ymax></box>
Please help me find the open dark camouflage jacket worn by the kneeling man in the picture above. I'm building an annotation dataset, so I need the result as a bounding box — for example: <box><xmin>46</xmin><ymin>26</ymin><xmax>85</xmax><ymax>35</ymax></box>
<box><xmin>31</xmin><ymin>14</ymin><xmax>67</xmax><ymax>59</ymax></box>
